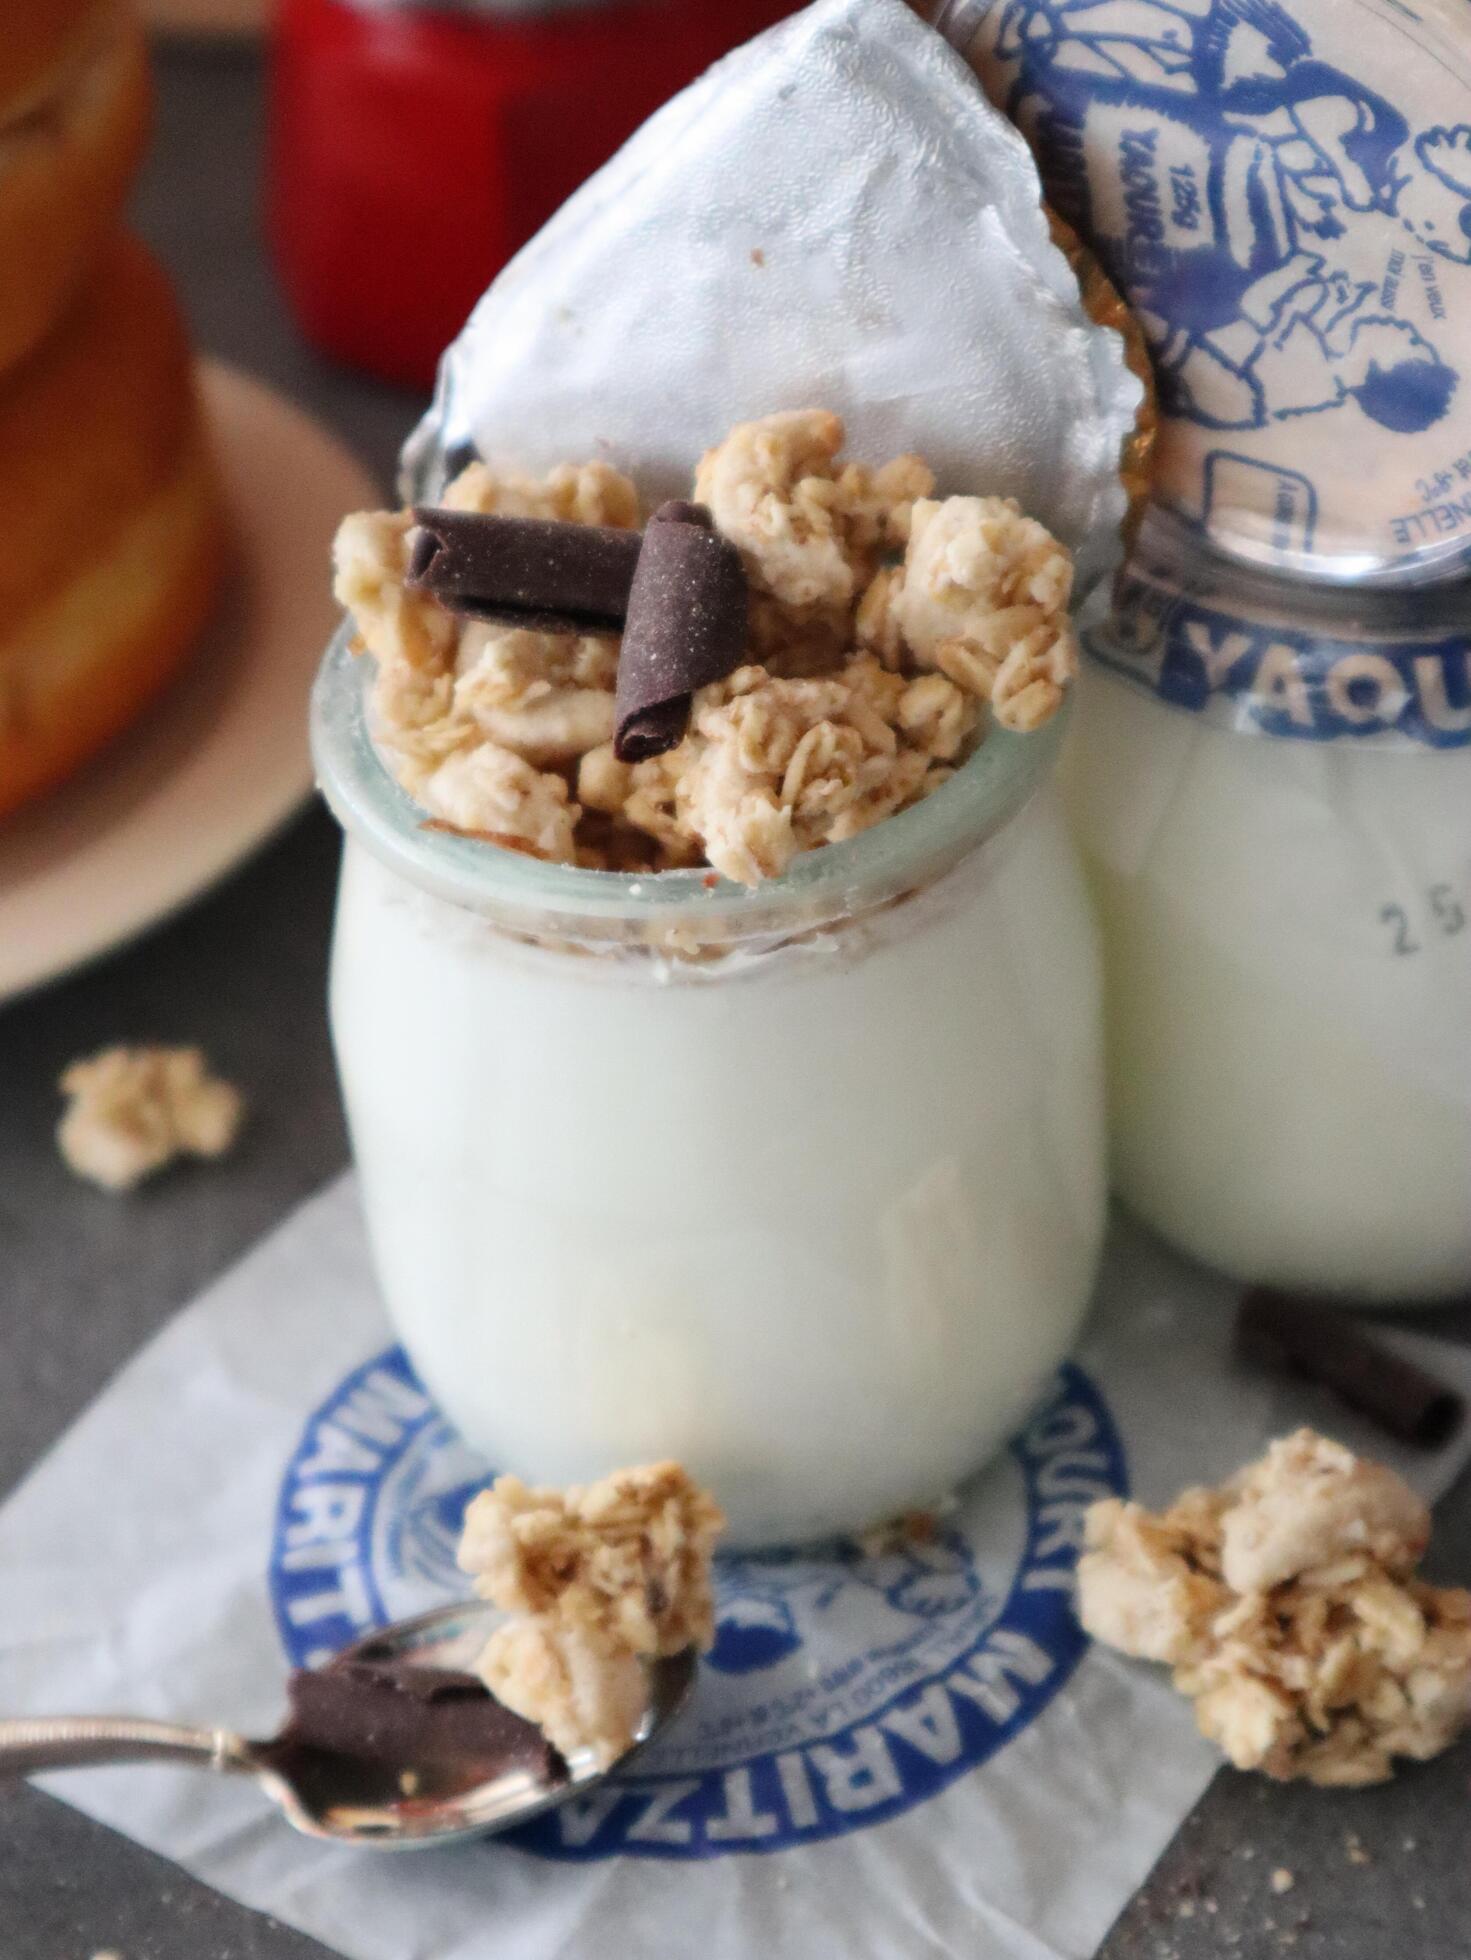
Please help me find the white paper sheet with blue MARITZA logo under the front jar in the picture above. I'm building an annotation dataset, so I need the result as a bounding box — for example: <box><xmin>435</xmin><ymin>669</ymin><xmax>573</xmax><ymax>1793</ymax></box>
<box><xmin>0</xmin><ymin>1180</ymin><xmax>1471</xmax><ymax>1960</ymax></box>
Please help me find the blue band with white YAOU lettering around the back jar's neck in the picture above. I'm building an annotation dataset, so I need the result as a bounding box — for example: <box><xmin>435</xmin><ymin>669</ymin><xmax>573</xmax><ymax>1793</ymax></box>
<box><xmin>1081</xmin><ymin>512</ymin><xmax>1471</xmax><ymax>749</ymax></box>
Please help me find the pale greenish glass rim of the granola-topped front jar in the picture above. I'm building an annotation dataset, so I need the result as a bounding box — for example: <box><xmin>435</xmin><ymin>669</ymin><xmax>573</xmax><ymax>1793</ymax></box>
<box><xmin>311</xmin><ymin>619</ymin><xmax>1069</xmax><ymax>937</ymax></box>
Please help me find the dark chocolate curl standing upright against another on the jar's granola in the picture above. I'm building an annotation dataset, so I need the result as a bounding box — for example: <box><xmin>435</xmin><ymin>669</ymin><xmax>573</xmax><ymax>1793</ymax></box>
<box><xmin>613</xmin><ymin>502</ymin><xmax>746</xmax><ymax>762</ymax></box>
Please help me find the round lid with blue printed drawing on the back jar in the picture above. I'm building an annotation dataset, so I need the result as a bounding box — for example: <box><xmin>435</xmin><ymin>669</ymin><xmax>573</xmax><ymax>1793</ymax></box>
<box><xmin>936</xmin><ymin>0</ymin><xmax>1471</xmax><ymax>584</ymax></box>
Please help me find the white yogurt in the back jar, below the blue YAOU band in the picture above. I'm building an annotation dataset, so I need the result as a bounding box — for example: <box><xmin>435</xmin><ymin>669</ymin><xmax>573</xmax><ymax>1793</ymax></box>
<box><xmin>1066</xmin><ymin>638</ymin><xmax>1471</xmax><ymax>1301</ymax></box>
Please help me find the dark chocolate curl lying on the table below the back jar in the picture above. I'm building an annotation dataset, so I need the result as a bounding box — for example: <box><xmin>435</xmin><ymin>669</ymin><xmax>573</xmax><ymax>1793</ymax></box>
<box><xmin>1236</xmin><ymin>1286</ymin><xmax>1465</xmax><ymax>1448</ymax></box>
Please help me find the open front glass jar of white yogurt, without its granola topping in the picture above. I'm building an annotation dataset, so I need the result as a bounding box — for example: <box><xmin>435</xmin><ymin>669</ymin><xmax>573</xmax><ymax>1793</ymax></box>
<box><xmin>313</xmin><ymin>637</ymin><xmax>1105</xmax><ymax>1544</ymax></box>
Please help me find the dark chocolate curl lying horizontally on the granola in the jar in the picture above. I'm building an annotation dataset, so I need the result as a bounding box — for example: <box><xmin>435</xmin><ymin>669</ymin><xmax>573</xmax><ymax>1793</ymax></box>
<box><xmin>407</xmin><ymin>510</ymin><xmax>641</xmax><ymax>633</ymax></box>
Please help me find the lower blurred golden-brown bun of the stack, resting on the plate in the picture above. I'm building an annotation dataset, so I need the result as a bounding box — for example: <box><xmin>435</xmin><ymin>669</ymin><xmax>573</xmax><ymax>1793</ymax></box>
<box><xmin>0</xmin><ymin>233</ymin><xmax>225</xmax><ymax>815</ymax></box>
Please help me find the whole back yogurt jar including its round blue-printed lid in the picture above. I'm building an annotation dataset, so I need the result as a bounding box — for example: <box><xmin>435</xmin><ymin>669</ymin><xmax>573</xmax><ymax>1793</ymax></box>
<box><xmin>934</xmin><ymin>0</ymin><xmax>1471</xmax><ymax>1303</ymax></box>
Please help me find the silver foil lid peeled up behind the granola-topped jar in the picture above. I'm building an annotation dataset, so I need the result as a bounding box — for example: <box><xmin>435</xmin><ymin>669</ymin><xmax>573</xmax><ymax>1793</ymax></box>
<box><xmin>403</xmin><ymin>0</ymin><xmax>1142</xmax><ymax>592</ymax></box>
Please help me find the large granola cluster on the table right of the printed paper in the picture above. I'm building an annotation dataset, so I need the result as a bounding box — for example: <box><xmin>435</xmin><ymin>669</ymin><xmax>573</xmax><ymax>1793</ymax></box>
<box><xmin>1077</xmin><ymin>1429</ymin><xmax>1471</xmax><ymax>1786</ymax></box>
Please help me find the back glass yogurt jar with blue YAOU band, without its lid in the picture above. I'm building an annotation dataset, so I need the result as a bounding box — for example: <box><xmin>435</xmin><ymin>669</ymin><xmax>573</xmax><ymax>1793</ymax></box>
<box><xmin>1068</xmin><ymin>515</ymin><xmax>1471</xmax><ymax>1303</ymax></box>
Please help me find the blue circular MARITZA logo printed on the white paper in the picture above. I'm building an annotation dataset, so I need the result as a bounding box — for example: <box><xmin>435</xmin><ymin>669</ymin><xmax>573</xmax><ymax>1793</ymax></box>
<box><xmin>270</xmin><ymin>1348</ymin><xmax>1128</xmax><ymax>1858</ymax></box>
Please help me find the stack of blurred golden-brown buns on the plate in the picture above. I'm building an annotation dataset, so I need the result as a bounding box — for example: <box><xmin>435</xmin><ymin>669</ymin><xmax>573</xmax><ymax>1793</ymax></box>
<box><xmin>0</xmin><ymin>0</ymin><xmax>225</xmax><ymax>817</ymax></box>
